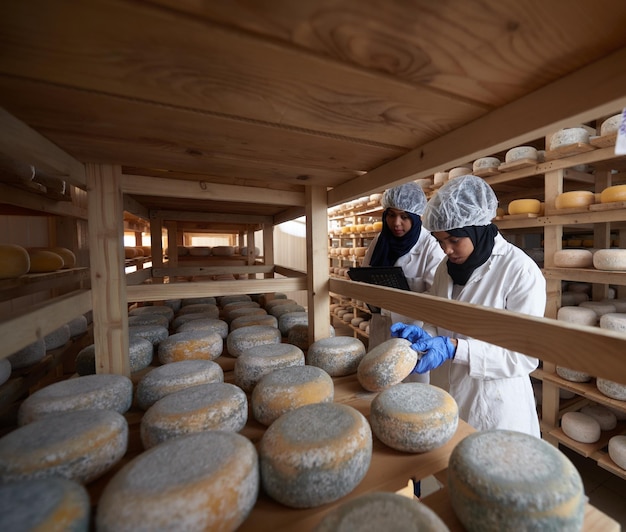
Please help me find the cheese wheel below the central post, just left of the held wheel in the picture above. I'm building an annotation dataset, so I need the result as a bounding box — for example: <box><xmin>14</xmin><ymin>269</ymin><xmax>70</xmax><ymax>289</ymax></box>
<box><xmin>307</xmin><ymin>336</ymin><xmax>366</xmax><ymax>377</ymax></box>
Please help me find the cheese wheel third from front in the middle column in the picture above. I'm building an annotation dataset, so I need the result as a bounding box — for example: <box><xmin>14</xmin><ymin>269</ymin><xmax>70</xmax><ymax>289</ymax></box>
<box><xmin>234</xmin><ymin>343</ymin><xmax>304</xmax><ymax>392</ymax></box>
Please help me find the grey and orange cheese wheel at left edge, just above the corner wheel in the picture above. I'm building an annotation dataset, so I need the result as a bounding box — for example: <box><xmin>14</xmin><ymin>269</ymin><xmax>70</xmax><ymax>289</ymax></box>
<box><xmin>0</xmin><ymin>410</ymin><xmax>128</xmax><ymax>484</ymax></box>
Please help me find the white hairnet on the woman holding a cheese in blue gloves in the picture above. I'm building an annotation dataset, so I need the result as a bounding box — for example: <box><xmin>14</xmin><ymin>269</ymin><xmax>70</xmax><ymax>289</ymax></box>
<box><xmin>422</xmin><ymin>175</ymin><xmax>498</xmax><ymax>232</ymax></box>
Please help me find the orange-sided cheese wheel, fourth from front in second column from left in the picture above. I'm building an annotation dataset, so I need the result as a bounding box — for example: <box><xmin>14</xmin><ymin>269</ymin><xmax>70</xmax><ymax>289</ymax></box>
<box><xmin>157</xmin><ymin>329</ymin><xmax>224</xmax><ymax>364</ymax></box>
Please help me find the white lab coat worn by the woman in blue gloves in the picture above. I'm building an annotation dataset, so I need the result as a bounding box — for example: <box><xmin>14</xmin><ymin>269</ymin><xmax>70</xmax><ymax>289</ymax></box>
<box><xmin>431</xmin><ymin>234</ymin><xmax>546</xmax><ymax>437</ymax></box>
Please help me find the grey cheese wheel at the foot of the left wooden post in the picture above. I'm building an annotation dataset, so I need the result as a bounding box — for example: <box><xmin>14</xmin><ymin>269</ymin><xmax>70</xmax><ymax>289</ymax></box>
<box><xmin>17</xmin><ymin>373</ymin><xmax>133</xmax><ymax>425</ymax></box>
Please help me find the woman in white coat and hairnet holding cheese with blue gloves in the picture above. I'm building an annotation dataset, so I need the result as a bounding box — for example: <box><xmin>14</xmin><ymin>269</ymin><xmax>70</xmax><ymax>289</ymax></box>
<box><xmin>394</xmin><ymin>176</ymin><xmax>546</xmax><ymax>437</ymax></box>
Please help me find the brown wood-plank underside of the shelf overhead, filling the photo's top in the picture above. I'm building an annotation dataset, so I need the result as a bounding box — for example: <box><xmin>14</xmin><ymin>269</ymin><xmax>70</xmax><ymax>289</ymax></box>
<box><xmin>0</xmin><ymin>0</ymin><xmax>626</xmax><ymax>217</ymax></box>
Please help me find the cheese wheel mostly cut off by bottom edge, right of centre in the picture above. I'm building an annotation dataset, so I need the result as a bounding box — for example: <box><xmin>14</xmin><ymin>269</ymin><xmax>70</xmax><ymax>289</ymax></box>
<box><xmin>314</xmin><ymin>491</ymin><xmax>450</xmax><ymax>532</ymax></box>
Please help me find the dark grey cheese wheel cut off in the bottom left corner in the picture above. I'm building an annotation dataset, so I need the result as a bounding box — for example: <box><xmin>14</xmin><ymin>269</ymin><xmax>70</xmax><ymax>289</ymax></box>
<box><xmin>0</xmin><ymin>477</ymin><xmax>91</xmax><ymax>532</ymax></box>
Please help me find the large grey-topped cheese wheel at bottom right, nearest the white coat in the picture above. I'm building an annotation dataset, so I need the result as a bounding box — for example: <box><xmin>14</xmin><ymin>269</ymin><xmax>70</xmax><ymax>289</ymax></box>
<box><xmin>448</xmin><ymin>430</ymin><xmax>586</xmax><ymax>530</ymax></box>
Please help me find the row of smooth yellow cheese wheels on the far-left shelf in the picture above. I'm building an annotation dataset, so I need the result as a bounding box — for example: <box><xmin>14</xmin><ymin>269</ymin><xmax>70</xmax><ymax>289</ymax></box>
<box><xmin>0</xmin><ymin>244</ymin><xmax>76</xmax><ymax>279</ymax></box>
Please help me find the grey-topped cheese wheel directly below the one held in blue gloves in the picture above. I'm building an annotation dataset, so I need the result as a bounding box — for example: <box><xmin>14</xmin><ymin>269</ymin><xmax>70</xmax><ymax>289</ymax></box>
<box><xmin>370</xmin><ymin>382</ymin><xmax>459</xmax><ymax>453</ymax></box>
